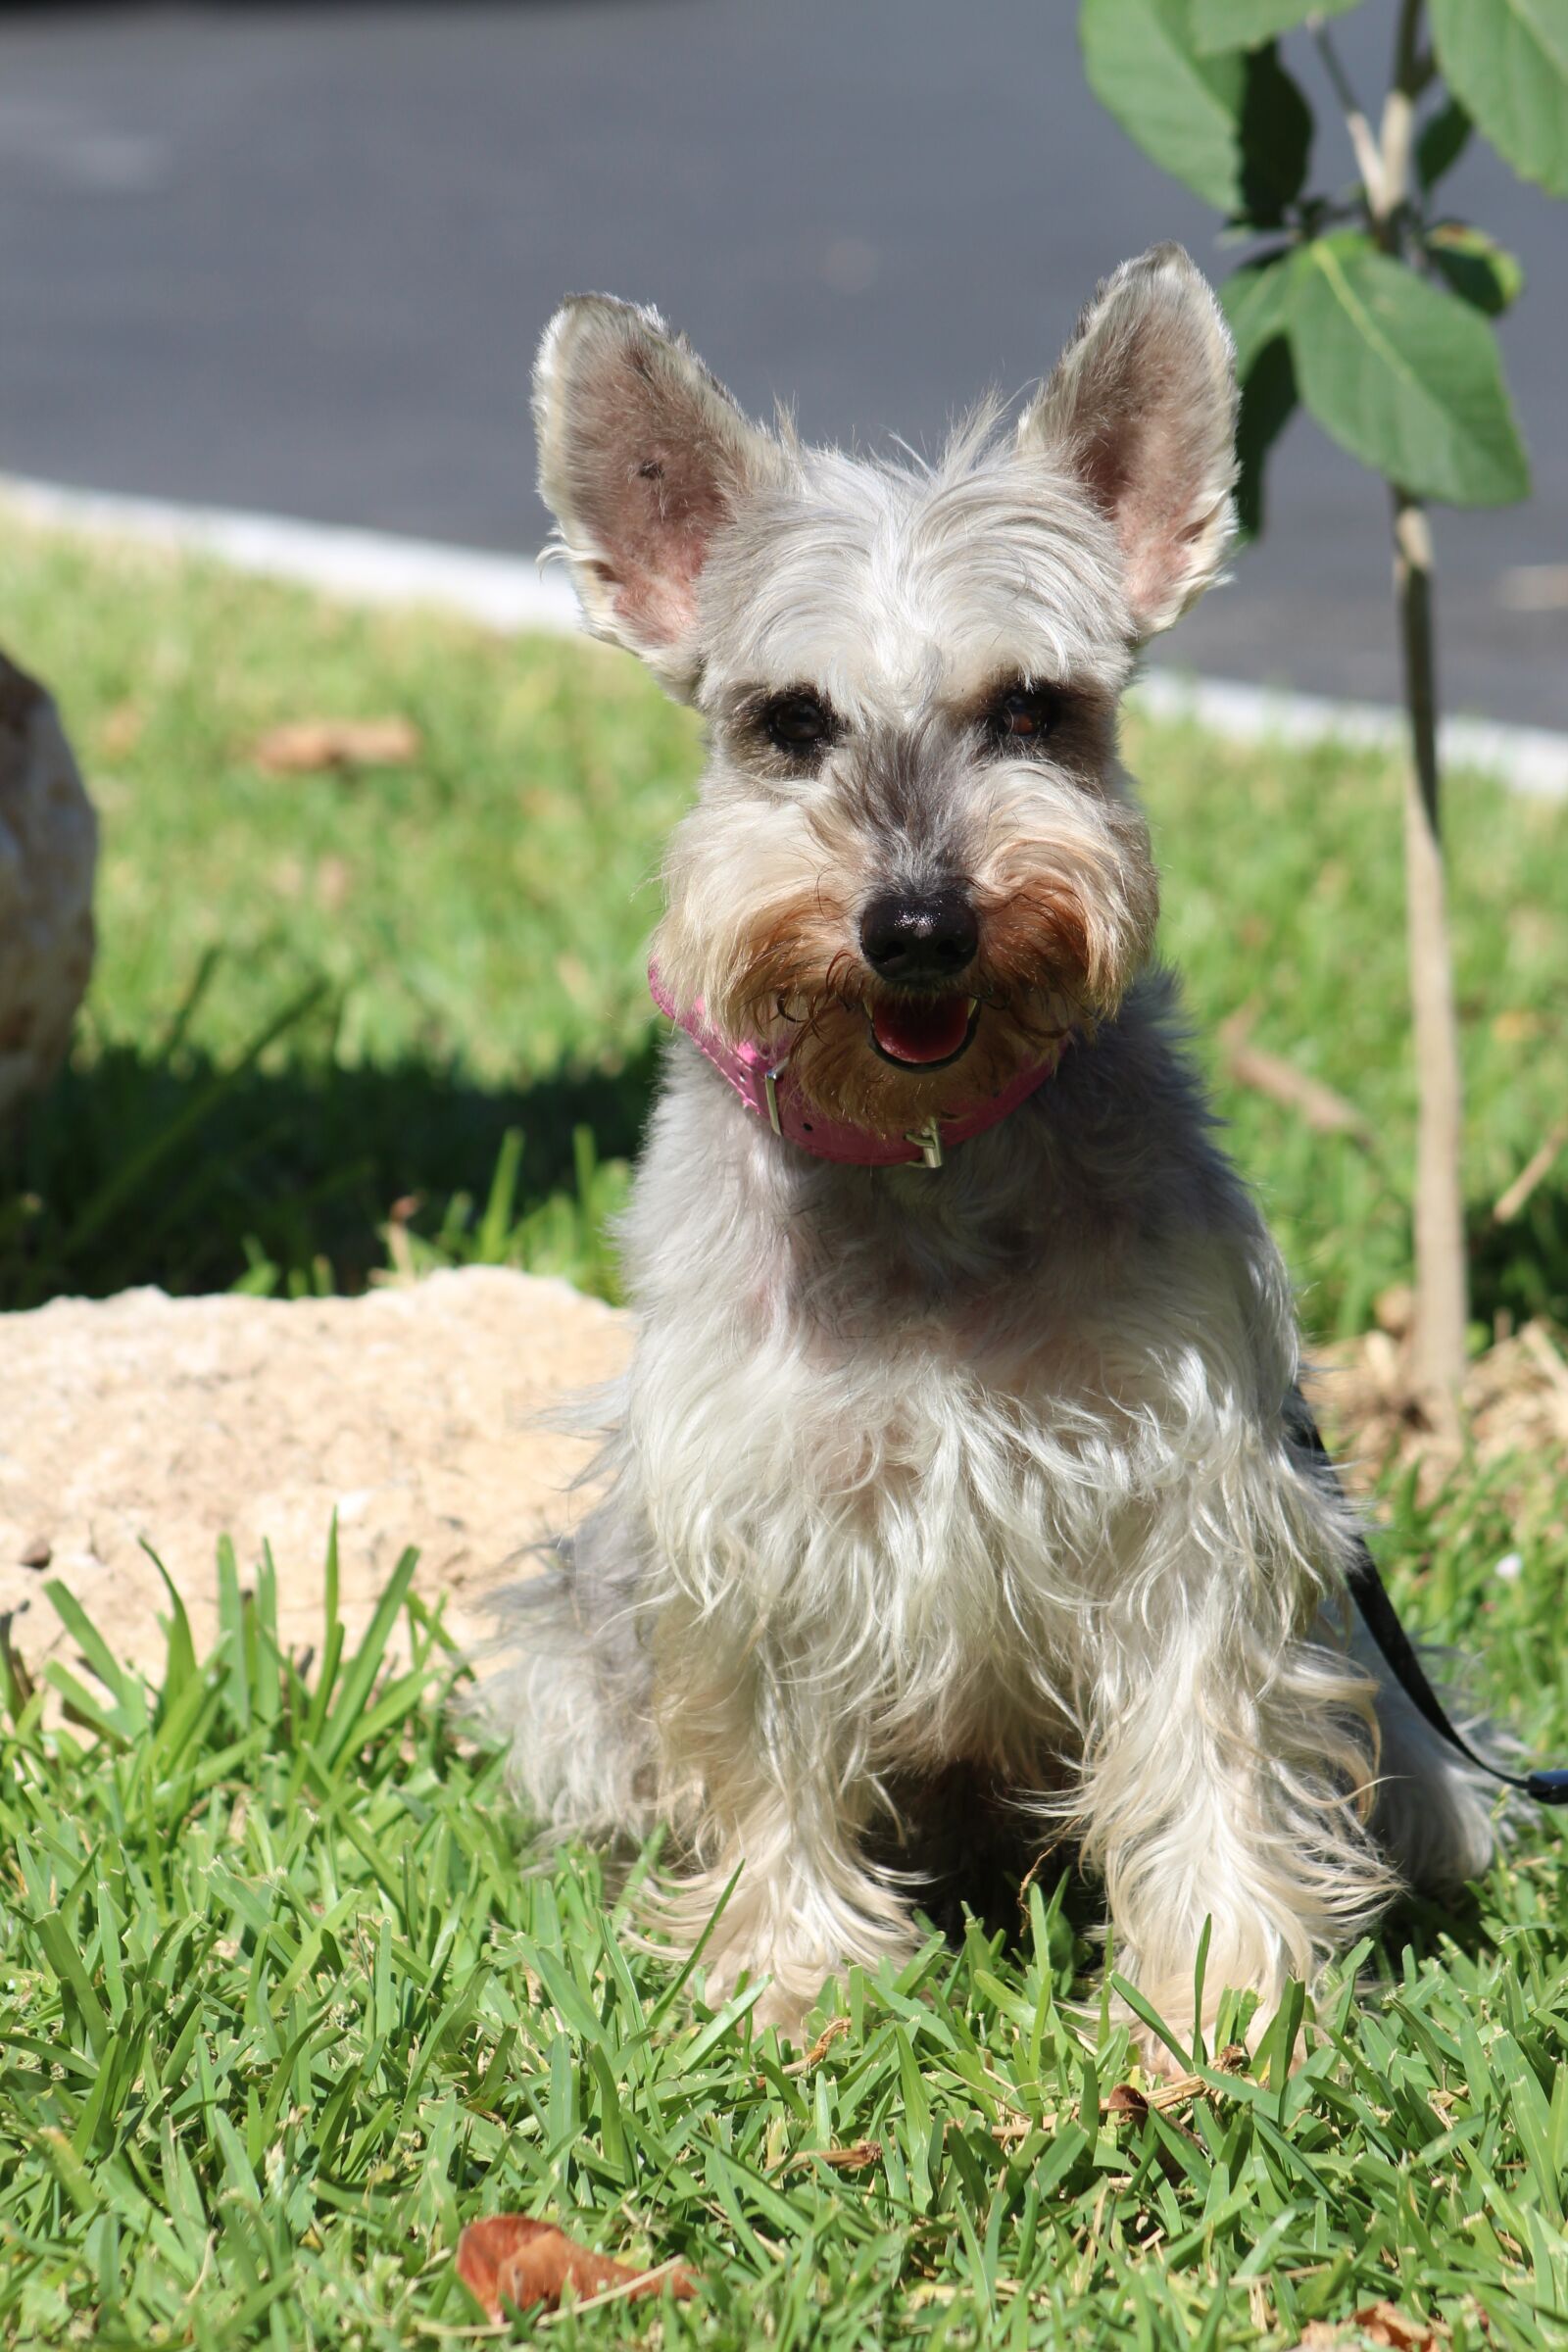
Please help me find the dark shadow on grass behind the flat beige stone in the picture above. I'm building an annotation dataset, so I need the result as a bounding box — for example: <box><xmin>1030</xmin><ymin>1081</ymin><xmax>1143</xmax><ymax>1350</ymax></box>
<box><xmin>0</xmin><ymin>1040</ymin><xmax>656</xmax><ymax>1307</ymax></box>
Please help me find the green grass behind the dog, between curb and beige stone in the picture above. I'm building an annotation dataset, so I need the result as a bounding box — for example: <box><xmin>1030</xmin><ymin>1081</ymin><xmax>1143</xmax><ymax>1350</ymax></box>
<box><xmin>0</xmin><ymin>529</ymin><xmax>1568</xmax><ymax>1334</ymax></box>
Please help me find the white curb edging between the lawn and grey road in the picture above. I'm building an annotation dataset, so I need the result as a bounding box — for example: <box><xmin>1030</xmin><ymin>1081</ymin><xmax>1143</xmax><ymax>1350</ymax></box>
<box><xmin>0</xmin><ymin>475</ymin><xmax>1568</xmax><ymax>798</ymax></box>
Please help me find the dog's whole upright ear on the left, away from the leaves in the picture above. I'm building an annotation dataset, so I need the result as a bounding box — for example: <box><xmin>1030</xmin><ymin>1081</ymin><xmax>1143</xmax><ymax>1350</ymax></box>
<box><xmin>534</xmin><ymin>294</ymin><xmax>783</xmax><ymax>694</ymax></box>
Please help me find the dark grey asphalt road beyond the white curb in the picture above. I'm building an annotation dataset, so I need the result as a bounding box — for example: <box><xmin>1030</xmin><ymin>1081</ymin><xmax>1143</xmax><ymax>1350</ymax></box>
<box><xmin>0</xmin><ymin>0</ymin><xmax>1568</xmax><ymax>727</ymax></box>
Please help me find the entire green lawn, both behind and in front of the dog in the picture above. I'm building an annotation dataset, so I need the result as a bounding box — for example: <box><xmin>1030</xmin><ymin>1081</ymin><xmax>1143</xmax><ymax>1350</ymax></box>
<box><xmin>0</xmin><ymin>519</ymin><xmax>1568</xmax><ymax>2352</ymax></box>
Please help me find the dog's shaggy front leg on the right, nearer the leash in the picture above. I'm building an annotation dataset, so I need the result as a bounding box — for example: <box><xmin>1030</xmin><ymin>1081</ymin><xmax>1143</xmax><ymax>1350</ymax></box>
<box><xmin>1081</xmin><ymin>1611</ymin><xmax>1396</xmax><ymax>2068</ymax></box>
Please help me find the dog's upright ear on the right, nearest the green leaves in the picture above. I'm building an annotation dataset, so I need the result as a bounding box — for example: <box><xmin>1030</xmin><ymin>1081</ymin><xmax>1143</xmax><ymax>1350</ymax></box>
<box><xmin>1018</xmin><ymin>245</ymin><xmax>1237</xmax><ymax>640</ymax></box>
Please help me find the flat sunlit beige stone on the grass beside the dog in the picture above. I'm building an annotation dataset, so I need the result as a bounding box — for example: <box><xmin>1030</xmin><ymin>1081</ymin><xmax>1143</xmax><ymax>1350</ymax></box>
<box><xmin>0</xmin><ymin>1268</ymin><xmax>630</xmax><ymax>1675</ymax></box>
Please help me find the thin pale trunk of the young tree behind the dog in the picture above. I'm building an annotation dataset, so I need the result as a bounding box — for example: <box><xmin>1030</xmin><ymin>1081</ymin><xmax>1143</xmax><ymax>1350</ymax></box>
<box><xmin>1394</xmin><ymin>489</ymin><xmax>1469</xmax><ymax>1423</ymax></box>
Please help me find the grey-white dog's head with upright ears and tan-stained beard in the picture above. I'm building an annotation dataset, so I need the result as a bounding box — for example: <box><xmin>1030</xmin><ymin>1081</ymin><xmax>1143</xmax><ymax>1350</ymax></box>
<box><xmin>536</xmin><ymin>245</ymin><xmax>1237</xmax><ymax>1134</ymax></box>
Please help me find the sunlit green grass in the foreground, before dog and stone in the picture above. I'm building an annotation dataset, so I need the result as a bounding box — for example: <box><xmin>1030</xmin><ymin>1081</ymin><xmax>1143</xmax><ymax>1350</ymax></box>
<box><xmin>0</xmin><ymin>1482</ymin><xmax>1568</xmax><ymax>2352</ymax></box>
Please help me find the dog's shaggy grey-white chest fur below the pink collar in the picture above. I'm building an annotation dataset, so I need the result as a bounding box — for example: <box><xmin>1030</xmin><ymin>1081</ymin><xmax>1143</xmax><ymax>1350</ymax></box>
<box><xmin>625</xmin><ymin>986</ymin><xmax>1293</xmax><ymax>1754</ymax></box>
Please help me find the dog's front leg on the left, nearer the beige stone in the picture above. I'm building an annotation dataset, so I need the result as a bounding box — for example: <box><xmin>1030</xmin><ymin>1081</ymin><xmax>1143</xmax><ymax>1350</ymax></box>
<box><xmin>659</xmin><ymin>1630</ymin><xmax>914</xmax><ymax>2033</ymax></box>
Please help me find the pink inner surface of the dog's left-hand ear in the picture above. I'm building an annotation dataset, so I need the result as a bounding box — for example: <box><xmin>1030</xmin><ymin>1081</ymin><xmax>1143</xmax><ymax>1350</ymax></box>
<box><xmin>566</xmin><ymin>336</ymin><xmax>741</xmax><ymax>645</ymax></box>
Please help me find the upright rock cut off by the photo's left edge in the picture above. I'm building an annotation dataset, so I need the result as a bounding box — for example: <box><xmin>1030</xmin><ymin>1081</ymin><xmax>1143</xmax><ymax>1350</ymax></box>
<box><xmin>0</xmin><ymin>654</ymin><xmax>99</xmax><ymax>1119</ymax></box>
